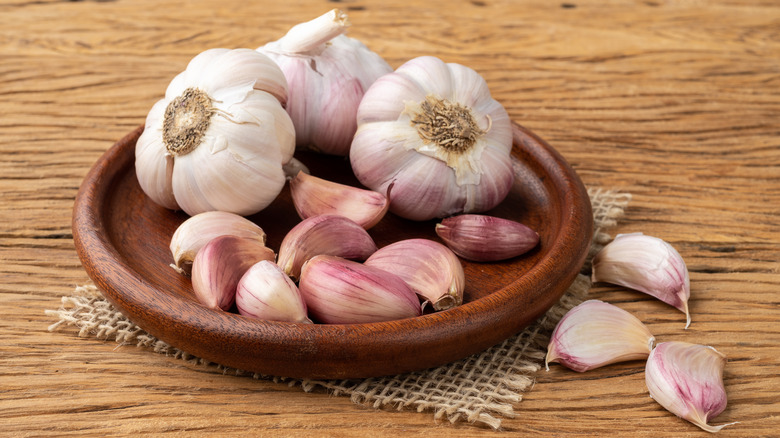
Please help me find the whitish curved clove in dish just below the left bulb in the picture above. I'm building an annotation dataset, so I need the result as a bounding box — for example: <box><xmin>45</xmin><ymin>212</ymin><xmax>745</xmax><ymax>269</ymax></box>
<box><xmin>170</xmin><ymin>211</ymin><xmax>266</xmax><ymax>274</ymax></box>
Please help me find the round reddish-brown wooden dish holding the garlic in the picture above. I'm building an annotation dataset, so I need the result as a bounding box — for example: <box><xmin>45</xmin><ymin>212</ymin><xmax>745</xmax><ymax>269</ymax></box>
<box><xmin>73</xmin><ymin>125</ymin><xmax>593</xmax><ymax>379</ymax></box>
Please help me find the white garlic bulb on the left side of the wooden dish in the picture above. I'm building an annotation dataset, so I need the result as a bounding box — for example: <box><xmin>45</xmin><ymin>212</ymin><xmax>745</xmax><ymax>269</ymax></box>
<box><xmin>135</xmin><ymin>49</ymin><xmax>295</xmax><ymax>216</ymax></box>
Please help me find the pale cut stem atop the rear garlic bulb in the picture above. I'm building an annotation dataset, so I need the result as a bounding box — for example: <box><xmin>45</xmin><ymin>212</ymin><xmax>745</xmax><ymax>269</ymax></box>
<box><xmin>279</xmin><ymin>9</ymin><xmax>350</xmax><ymax>54</ymax></box>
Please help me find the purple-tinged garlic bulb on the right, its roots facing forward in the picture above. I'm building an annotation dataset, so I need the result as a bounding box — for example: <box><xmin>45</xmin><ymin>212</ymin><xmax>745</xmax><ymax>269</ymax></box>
<box><xmin>349</xmin><ymin>56</ymin><xmax>514</xmax><ymax>220</ymax></box>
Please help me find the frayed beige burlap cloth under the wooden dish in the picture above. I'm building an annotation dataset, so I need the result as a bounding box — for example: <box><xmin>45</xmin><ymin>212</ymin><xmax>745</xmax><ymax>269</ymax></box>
<box><xmin>46</xmin><ymin>189</ymin><xmax>631</xmax><ymax>429</ymax></box>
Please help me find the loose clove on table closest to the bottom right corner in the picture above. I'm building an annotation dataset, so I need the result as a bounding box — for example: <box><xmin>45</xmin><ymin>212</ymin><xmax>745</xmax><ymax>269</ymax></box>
<box><xmin>645</xmin><ymin>342</ymin><xmax>735</xmax><ymax>432</ymax></box>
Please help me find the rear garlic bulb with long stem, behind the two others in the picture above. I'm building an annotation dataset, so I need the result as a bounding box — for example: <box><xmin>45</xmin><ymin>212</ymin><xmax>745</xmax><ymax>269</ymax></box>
<box><xmin>257</xmin><ymin>9</ymin><xmax>393</xmax><ymax>155</ymax></box>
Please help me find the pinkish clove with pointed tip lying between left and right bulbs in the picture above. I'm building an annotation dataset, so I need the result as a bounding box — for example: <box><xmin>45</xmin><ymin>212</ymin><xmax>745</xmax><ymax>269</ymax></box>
<box><xmin>290</xmin><ymin>172</ymin><xmax>390</xmax><ymax>229</ymax></box>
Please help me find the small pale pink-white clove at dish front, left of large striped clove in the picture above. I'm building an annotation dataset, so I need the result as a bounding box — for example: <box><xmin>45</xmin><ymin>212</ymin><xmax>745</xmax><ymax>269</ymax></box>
<box><xmin>236</xmin><ymin>260</ymin><xmax>311</xmax><ymax>324</ymax></box>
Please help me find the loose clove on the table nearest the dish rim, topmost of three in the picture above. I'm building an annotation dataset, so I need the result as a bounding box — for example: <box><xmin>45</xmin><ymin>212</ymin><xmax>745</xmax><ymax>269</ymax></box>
<box><xmin>592</xmin><ymin>233</ymin><xmax>691</xmax><ymax>328</ymax></box>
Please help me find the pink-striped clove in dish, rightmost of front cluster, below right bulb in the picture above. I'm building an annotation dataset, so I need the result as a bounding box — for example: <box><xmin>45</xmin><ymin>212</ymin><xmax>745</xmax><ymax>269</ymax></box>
<box><xmin>364</xmin><ymin>239</ymin><xmax>466</xmax><ymax>310</ymax></box>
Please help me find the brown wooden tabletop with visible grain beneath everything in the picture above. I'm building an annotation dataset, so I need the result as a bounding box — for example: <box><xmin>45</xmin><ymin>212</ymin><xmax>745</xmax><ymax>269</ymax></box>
<box><xmin>0</xmin><ymin>0</ymin><xmax>780</xmax><ymax>437</ymax></box>
